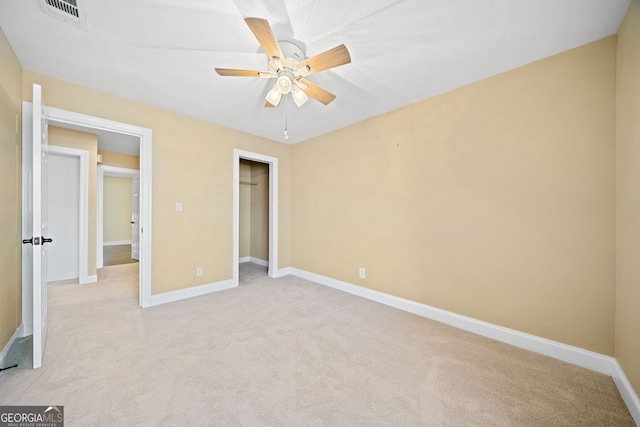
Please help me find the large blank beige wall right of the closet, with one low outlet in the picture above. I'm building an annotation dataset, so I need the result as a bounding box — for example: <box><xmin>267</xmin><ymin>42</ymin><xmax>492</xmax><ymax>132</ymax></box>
<box><xmin>291</xmin><ymin>37</ymin><xmax>616</xmax><ymax>355</ymax></box>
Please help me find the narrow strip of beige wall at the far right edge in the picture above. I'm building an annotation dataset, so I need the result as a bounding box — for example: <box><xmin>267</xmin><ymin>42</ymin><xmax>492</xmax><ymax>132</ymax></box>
<box><xmin>616</xmin><ymin>0</ymin><xmax>640</xmax><ymax>395</ymax></box>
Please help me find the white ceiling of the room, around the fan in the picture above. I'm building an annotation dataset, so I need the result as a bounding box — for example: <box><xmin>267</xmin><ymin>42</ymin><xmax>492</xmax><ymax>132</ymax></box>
<box><xmin>0</xmin><ymin>0</ymin><xmax>631</xmax><ymax>143</ymax></box>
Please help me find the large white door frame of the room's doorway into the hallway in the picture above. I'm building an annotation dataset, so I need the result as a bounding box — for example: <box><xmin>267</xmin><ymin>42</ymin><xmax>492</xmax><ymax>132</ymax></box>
<box><xmin>22</xmin><ymin>102</ymin><xmax>152</xmax><ymax>310</ymax></box>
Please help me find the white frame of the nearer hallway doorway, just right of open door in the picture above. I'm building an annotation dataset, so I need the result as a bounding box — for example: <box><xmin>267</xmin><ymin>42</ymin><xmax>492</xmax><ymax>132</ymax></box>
<box><xmin>49</xmin><ymin>145</ymin><xmax>98</xmax><ymax>285</ymax></box>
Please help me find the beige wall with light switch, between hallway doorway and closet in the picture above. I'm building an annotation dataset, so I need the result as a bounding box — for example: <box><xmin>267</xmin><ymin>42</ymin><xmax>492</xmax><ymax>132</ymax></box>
<box><xmin>23</xmin><ymin>70</ymin><xmax>291</xmax><ymax>294</ymax></box>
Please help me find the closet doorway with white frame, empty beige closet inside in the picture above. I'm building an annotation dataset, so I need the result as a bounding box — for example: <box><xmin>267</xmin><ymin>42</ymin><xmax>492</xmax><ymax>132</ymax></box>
<box><xmin>233</xmin><ymin>149</ymin><xmax>279</xmax><ymax>285</ymax></box>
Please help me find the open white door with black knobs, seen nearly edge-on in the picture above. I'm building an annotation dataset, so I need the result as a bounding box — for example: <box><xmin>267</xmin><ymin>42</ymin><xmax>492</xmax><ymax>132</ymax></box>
<box><xmin>28</xmin><ymin>84</ymin><xmax>51</xmax><ymax>369</ymax></box>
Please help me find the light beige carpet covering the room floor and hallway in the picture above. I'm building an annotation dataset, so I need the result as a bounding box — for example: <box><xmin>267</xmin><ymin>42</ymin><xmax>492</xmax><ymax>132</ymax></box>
<box><xmin>0</xmin><ymin>264</ymin><xmax>634</xmax><ymax>426</ymax></box>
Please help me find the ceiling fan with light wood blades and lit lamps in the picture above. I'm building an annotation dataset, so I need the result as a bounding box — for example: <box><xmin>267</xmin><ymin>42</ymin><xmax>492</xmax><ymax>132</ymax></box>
<box><xmin>215</xmin><ymin>18</ymin><xmax>351</xmax><ymax>107</ymax></box>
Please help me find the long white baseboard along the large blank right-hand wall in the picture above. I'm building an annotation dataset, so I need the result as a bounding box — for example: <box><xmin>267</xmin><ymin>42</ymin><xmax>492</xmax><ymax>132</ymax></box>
<box><xmin>291</xmin><ymin>268</ymin><xmax>615</xmax><ymax>376</ymax></box>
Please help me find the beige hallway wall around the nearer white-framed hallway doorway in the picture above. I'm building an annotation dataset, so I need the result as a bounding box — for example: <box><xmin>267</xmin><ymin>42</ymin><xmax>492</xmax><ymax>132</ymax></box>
<box><xmin>49</xmin><ymin>126</ymin><xmax>98</xmax><ymax>276</ymax></box>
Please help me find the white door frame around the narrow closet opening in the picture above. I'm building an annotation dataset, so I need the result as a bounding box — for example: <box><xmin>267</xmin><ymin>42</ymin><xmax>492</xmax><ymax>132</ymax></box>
<box><xmin>233</xmin><ymin>149</ymin><xmax>281</xmax><ymax>286</ymax></box>
